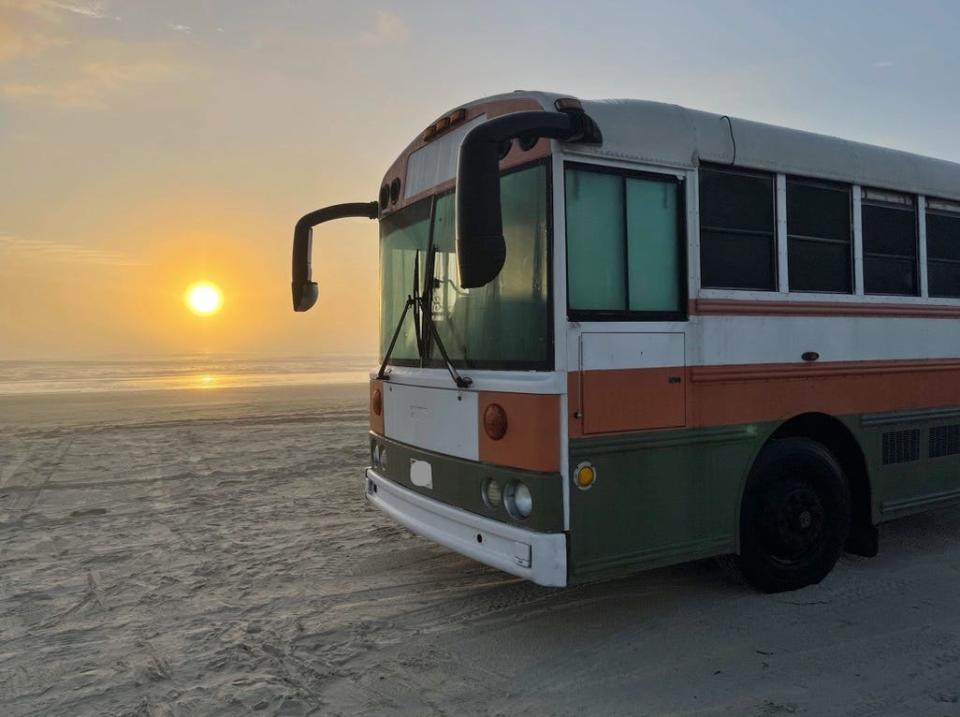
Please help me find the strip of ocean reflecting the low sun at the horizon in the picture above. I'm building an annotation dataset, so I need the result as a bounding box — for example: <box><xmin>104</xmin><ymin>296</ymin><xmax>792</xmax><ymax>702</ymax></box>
<box><xmin>0</xmin><ymin>354</ymin><xmax>377</xmax><ymax>395</ymax></box>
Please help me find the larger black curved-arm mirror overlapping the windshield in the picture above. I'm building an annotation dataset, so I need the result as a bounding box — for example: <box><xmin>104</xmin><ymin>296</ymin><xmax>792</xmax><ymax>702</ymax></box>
<box><xmin>456</xmin><ymin>100</ymin><xmax>603</xmax><ymax>289</ymax></box>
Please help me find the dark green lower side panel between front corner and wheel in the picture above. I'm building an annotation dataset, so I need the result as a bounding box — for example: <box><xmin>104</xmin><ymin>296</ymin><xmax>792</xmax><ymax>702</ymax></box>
<box><xmin>570</xmin><ymin>425</ymin><xmax>775</xmax><ymax>581</ymax></box>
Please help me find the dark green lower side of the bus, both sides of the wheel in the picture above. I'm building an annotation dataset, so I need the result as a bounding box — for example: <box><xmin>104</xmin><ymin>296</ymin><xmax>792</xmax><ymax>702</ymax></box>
<box><xmin>570</xmin><ymin>407</ymin><xmax>960</xmax><ymax>581</ymax></box>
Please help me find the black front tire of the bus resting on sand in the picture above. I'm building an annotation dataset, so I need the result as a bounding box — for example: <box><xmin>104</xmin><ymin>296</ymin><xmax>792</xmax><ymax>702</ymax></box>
<box><xmin>737</xmin><ymin>438</ymin><xmax>850</xmax><ymax>593</ymax></box>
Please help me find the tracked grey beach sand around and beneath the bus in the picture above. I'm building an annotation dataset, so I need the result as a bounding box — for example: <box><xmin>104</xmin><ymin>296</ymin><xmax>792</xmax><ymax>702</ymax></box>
<box><xmin>0</xmin><ymin>386</ymin><xmax>960</xmax><ymax>716</ymax></box>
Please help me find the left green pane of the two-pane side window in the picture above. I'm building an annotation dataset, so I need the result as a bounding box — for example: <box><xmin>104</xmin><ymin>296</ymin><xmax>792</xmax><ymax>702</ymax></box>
<box><xmin>566</xmin><ymin>169</ymin><xmax>627</xmax><ymax>311</ymax></box>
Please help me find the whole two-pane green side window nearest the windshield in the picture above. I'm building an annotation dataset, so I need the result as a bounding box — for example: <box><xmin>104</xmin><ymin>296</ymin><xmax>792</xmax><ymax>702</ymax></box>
<box><xmin>566</xmin><ymin>168</ymin><xmax>683</xmax><ymax>314</ymax></box>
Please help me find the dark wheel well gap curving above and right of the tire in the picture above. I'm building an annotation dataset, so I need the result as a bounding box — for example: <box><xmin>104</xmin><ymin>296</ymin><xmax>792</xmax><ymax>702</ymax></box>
<box><xmin>768</xmin><ymin>413</ymin><xmax>873</xmax><ymax>534</ymax></box>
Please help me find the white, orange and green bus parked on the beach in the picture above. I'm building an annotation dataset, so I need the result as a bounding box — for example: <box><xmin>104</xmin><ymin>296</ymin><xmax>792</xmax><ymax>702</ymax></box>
<box><xmin>293</xmin><ymin>92</ymin><xmax>960</xmax><ymax>592</ymax></box>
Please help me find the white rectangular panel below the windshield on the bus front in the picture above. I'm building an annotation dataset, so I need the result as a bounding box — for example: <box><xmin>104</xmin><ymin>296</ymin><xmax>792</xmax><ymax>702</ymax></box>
<box><xmin>383</xmin><ymin>382</ymin><xmax>480</xmax><ymax>461</ymax></box>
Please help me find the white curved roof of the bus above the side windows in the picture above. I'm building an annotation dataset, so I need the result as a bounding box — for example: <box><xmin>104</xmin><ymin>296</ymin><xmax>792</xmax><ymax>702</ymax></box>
<box><xmin>497</xmin><ymin>92</ymin><xmax>960</xmax><ymax>200</ymax></box>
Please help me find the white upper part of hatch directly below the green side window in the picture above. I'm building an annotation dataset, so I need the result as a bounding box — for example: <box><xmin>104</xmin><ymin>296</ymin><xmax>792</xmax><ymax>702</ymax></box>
<box><xmin>581</xmin><ymin>332</ymin><xmax>684</xmax><ymax>371</ymax></box>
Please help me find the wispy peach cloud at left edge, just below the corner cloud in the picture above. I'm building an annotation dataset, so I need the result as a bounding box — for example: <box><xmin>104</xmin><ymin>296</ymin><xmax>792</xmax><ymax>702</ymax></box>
<box><xmin>0</xmin><ymin>61</ymin><xmax>172</xmax><ymax>109</ymax></box>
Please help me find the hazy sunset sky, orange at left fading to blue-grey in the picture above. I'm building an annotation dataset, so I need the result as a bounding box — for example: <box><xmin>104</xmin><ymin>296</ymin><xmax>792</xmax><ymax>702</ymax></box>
<box><xmin>0</xmin><ymin>0</ymin><xmax>960</xmax><ymax>359</ymax></box>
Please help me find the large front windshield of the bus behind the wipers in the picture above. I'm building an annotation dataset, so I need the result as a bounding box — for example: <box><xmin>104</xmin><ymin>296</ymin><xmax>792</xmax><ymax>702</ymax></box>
<box><xmin>380</xmin><ymin>163</ymin><xmax>553</xmax><ymax>370</ymax></box>
